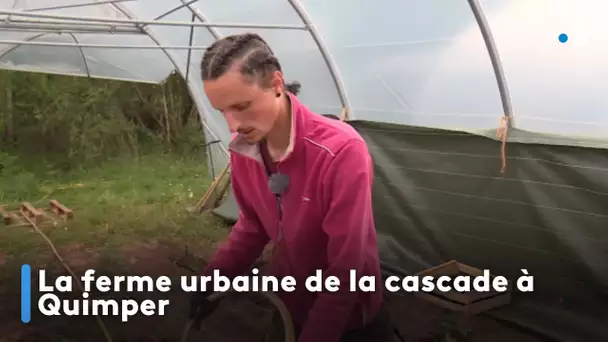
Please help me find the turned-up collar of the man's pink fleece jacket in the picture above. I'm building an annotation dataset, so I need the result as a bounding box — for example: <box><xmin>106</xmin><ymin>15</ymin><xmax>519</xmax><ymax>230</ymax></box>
<box><xmin>228</xmin><ymin>92</ymin><xmax>306</xmax><ymax>163</ymax></box>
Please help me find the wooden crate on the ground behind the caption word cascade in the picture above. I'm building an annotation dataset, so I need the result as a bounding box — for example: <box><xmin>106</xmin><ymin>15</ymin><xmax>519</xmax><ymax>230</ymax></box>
<box><xmin>416</xmin><ymin>260</ymin><xmax>512</xmax><ymax>316</ymax></box>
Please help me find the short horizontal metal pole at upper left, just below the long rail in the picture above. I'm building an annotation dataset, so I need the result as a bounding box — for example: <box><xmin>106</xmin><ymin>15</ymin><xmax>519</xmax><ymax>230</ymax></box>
<box><xmin>0</xmin><ymin>21</ymin><xmax>143</xmax><ymax>34</ymax></box>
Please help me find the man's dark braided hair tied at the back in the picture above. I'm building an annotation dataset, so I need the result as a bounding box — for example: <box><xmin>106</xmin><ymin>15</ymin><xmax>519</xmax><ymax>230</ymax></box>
<box><xmin>201</xmin><ymin>33</ymin><xmax>302</xmax><ymax>95</ymax></box>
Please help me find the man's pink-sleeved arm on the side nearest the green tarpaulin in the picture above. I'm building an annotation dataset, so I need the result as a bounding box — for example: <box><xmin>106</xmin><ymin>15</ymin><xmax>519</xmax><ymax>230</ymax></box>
<box><xmin>298</xmin><ymin>140</ymin><xmax>373</xmax><ymax>342</ymax></box>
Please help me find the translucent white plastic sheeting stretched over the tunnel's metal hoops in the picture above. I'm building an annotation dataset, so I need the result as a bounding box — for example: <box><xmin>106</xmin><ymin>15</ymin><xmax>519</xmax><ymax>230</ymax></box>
<box><xmin>0</xmin><ymin>0</ymin><xmax>608</xmax><ymax>156</ymax></box>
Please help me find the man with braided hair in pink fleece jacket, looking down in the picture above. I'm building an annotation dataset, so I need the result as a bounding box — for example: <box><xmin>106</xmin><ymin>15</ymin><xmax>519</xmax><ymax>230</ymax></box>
<box><xmin>190</xmin><ymin>33</ymin><xmax>393</xmax><ymax>342</ymax></box>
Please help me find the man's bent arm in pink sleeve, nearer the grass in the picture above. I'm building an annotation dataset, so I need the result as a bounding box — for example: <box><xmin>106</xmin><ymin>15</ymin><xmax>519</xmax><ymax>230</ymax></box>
<box><xmin>202</xmin><ymin>156</ymin><xmax>269</xmax><ymax>277</ymax></box>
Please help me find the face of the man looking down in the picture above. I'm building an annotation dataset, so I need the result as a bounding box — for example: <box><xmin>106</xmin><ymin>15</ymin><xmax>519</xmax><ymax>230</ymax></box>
<box><xmin>204</xmin><ymin>68</ymin><xmax>282</xmax><ymax>144</ymax></box>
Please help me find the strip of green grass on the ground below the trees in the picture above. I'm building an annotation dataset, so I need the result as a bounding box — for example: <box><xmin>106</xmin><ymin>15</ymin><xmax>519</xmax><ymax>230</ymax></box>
<box><xmin>0</xmin><ymin>153</ymin><xmax>227</xmax><ymax>272</ymax></box>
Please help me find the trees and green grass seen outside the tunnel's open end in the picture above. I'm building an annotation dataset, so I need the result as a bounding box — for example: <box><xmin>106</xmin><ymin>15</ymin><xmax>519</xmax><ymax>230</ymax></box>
<box><xmin>0</xmin><ymin>71</ymin><xmax>218</xmax><ymax>272</ymax></box>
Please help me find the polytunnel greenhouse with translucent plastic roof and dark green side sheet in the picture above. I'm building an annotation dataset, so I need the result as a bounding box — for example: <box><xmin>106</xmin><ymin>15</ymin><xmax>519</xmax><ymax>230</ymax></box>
<box><xmin>0</xmin><ymin>0</ymin><xmax>608</xmax><ymax>341</ymax></box>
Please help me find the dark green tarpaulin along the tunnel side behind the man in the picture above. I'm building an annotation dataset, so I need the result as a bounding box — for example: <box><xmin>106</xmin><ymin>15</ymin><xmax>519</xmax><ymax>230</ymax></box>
<box><xmin>215</xmin><ymin>122</ymin><xmax>608</xmax><ymax>341</ymax></box>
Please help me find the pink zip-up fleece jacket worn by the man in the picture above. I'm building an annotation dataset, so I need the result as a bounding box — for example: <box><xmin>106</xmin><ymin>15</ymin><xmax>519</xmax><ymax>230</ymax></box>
<box><xmin>203</xmin><ymin>94</ymin><xmax>383</xmax><ymax>342</ymax></box>
